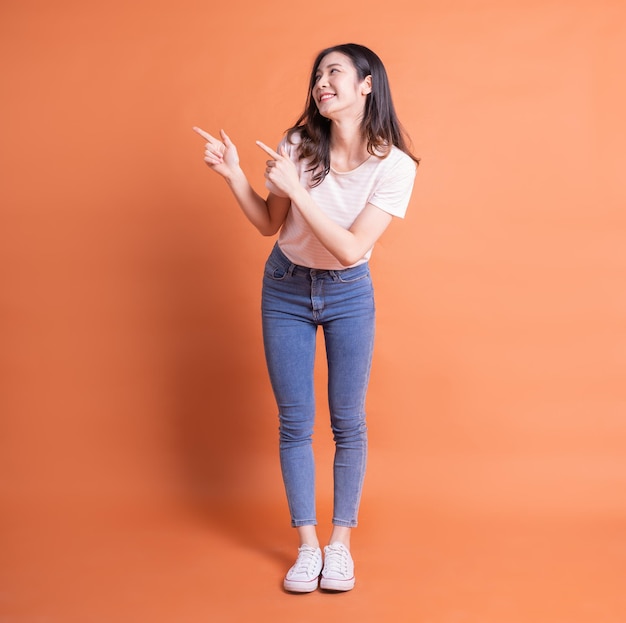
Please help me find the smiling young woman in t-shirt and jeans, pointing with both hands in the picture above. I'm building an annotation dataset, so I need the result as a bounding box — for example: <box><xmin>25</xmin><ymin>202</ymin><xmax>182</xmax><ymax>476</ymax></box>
<box><xmin>194</xmin><ymin>44</ymin><xmax>418</xmax><ymax>592</ymax></box>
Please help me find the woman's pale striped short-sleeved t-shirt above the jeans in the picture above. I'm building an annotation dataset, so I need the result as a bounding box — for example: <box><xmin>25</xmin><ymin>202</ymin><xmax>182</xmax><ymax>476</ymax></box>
<box><xmin>266</xmin><ymin>135</ymin><xmax>416</xmax><ymax>270</ymax></box>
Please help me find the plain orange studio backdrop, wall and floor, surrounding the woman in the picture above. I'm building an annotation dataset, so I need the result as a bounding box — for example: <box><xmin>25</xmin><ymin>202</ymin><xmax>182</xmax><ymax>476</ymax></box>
<box><xmin>0</xmin><ymin>0</ymin><xmax>626</xmax><ymax>623</ymax></box>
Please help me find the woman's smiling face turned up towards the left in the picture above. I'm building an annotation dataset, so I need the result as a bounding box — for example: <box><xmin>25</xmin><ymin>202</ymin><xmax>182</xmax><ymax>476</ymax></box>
<box><xmin>311</xmin><ymin>52</ymin><xmax>372</xmax><ymax>119</ymax></box>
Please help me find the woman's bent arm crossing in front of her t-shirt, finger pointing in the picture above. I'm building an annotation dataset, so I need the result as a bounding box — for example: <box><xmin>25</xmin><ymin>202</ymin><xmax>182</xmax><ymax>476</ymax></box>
<box><xmin>257</xmin><ymin>141</ymin><xmax>393</xmax><ymax>266</ymax></box>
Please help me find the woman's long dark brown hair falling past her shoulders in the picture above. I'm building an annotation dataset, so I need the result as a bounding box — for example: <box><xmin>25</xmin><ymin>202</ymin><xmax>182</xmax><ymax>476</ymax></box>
<box><xmin>287</xmin><ymin>43</ymin><xmax>419</xmax><ymax>186</ymax></box>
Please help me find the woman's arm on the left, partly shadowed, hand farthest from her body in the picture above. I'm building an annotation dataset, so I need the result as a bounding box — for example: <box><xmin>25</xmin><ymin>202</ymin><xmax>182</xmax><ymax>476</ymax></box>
<box><xmin>194</xmin><ymin>127</ymin><xmax>291</xmax><ymax>236</ymax></box>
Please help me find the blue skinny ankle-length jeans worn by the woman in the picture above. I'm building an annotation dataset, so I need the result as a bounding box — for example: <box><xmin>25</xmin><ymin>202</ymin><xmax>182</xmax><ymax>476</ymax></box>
<box><xmin>262</xmin><ymin>245</ymin><xmax>375</xmax><ymax>527</ymax></box>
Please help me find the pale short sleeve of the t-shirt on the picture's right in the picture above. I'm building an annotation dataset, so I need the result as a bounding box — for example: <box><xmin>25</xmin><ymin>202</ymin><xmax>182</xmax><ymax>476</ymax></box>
<box><xmin>368</xmin><ymin>149</ymin><xmax>417</xmax><ymax>218</ymax></box>
